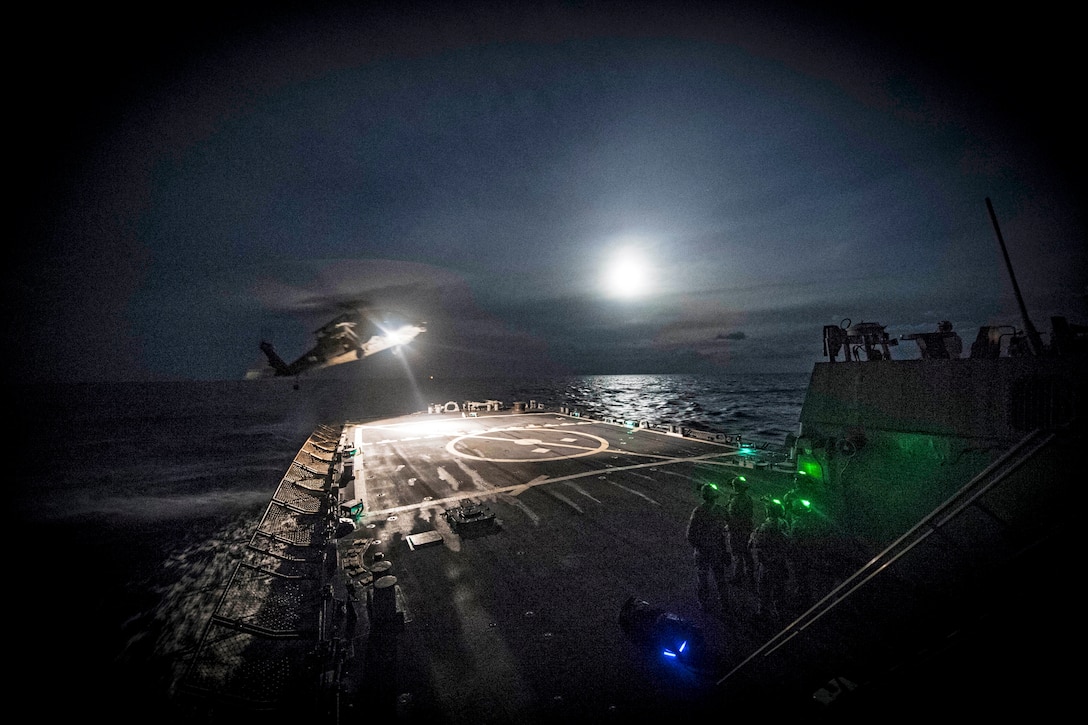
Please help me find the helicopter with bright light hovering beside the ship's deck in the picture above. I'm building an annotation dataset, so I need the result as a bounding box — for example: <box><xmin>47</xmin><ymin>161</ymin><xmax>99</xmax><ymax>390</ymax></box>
<box><xmin>259</xmin><ymin>308</ymin><xmax>426</xmax><ymax>377</ymax></box>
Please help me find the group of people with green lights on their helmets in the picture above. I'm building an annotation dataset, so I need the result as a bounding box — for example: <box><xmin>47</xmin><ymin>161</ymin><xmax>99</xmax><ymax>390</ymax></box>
<box><xmin>688</xmin><ymin>476</ymin><xmax>830</xmax><ymax>620</ymax></box>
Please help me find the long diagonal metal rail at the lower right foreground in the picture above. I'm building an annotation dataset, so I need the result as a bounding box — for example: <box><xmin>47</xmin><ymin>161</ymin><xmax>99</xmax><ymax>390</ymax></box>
<box><xmin>717</xmin><ymin>429</ymin><xmax>1058</xmax><ymax>686</ymax></box>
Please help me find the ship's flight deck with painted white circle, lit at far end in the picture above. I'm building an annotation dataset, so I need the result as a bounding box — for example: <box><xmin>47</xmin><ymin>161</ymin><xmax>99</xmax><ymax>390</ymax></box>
<box><xmin>339</xmin><ymin>411</ymin><xmax>790</xmax><ymax>723</ymax></box>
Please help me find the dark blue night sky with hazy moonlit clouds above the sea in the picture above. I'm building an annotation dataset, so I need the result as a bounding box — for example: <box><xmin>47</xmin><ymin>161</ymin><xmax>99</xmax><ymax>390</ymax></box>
<box><xmin>4</xmin><ymin>2</ymin><xmax>1088</xmax><ymax>381</ymax></box>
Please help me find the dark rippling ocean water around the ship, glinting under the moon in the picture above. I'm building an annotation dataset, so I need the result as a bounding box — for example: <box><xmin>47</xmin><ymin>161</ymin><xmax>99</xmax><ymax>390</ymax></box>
<box><xmin>8</xmin><ymin>373</ymin><xmax>808</xmax><ymax>722</ymax></box>
